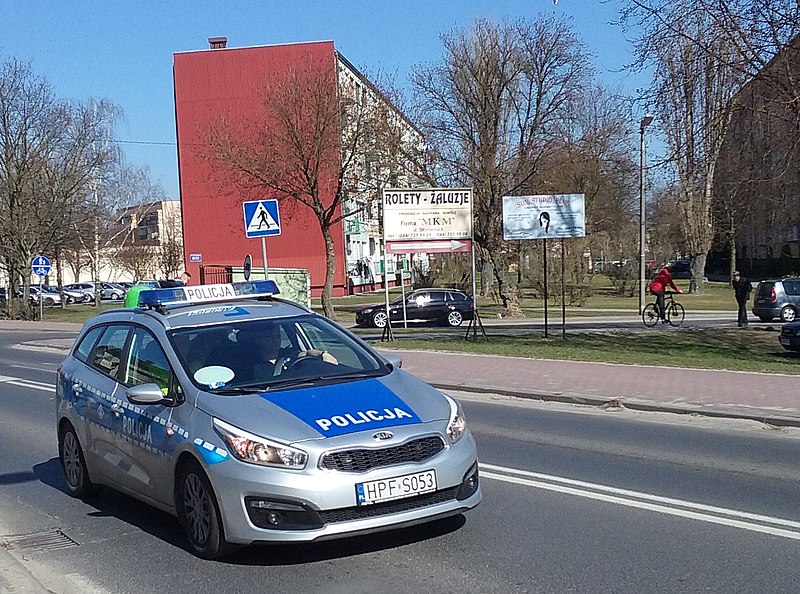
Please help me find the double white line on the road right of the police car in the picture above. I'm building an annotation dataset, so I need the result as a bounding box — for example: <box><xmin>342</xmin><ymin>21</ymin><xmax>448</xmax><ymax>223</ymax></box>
<box><xmin>480</xmin><ymin>463</ymin><xmax>800</xmax><ymax>540</ymax></box>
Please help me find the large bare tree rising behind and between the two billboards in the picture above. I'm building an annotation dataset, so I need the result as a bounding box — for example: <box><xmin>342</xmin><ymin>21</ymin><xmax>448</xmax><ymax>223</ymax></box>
<box><xmin>412</xmin><ymin>19</ymin><xmax>588</xmax><ymax>316</ymax></box>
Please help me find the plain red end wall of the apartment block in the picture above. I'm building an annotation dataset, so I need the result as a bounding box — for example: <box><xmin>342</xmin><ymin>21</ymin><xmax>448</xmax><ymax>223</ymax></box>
<box><xmin>173</xmin><ymin>42</ymin><xmax>346</xmax><ymax>296</ymax></box>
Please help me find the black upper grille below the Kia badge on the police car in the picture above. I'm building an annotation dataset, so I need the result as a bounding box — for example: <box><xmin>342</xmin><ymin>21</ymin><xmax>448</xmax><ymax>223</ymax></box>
<box><xmin>319</xmin><ymin>436</ymin><xmax>444</xmax><ymax>472</ymax></box>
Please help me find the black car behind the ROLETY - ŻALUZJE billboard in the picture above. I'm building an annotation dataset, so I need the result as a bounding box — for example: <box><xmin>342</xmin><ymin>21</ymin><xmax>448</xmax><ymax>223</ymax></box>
<box><xmin>356</xmin><ymin>289</ymin><xmax>475</xmax><ymax>328</ymax></box>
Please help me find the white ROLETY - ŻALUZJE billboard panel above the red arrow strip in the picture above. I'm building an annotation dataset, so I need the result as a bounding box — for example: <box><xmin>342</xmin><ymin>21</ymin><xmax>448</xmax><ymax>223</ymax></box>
<box><xmin>382</xmin><ymin>188</ymin><xmax>472</xmax><ymax>242</ymax></box>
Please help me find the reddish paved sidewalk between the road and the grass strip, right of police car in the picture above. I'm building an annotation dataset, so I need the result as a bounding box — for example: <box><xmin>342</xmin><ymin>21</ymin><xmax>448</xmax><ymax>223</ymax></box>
<box><xmin>390</xmin><ymin>347</ymin><xmax>800</xmax><ymax>426</ymax></box>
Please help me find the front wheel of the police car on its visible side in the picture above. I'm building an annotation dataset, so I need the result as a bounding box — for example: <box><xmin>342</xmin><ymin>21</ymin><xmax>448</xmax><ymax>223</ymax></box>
<box><xmin>175</xmin><ymin>462</ymin><xmax>233</xmax><ymax>559</ymax></box>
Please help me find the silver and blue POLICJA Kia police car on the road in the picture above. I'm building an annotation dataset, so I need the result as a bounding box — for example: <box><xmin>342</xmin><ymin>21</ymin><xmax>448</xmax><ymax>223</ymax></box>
<box><xmin>56</xmin><ymin>281</ymin><xmax>481</xmax><ymax>558</ymax></box>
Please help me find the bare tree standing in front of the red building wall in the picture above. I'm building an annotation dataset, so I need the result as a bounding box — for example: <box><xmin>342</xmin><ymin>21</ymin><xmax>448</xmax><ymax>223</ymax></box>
<box><xmin>201</xmin><ymin>54</ymin><xmax>412</xmax><ymax>319</ymax></box>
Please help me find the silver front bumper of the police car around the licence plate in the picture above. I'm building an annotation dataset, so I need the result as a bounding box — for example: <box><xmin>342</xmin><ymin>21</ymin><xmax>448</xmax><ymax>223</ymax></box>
<box><xmin>207</xmin><ymin>433</ymin><xmax>481</xmax><ymax>544</ymax></box>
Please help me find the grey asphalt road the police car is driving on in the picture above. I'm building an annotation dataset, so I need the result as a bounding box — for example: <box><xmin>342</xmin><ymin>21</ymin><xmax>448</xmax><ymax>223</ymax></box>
<box><xmin>0</xmin><ymin>332</ymin><xmax>800</xmax><ymax>594</ymax></box>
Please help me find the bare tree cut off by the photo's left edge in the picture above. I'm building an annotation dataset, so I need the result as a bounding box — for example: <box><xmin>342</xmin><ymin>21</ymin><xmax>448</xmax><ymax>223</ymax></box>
<box><xmin>0</xmin><ymin>60</ymin><xmax>113</xmax><ymax>315</ymax></box>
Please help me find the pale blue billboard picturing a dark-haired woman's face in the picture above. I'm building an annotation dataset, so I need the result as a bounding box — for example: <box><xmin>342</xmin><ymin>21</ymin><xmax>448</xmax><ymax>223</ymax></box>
<box><xmin>503</xmin><ymin>194</ymin><xmax>586</xmax><ymax>240</ymax></box>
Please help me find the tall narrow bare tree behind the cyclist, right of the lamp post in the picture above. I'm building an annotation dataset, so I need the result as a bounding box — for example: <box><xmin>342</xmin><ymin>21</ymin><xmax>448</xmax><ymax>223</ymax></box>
<box><xmin>625</xmin><ymin>0</ymin><xmax>745</xmax><ymax>292</ymax></box>
